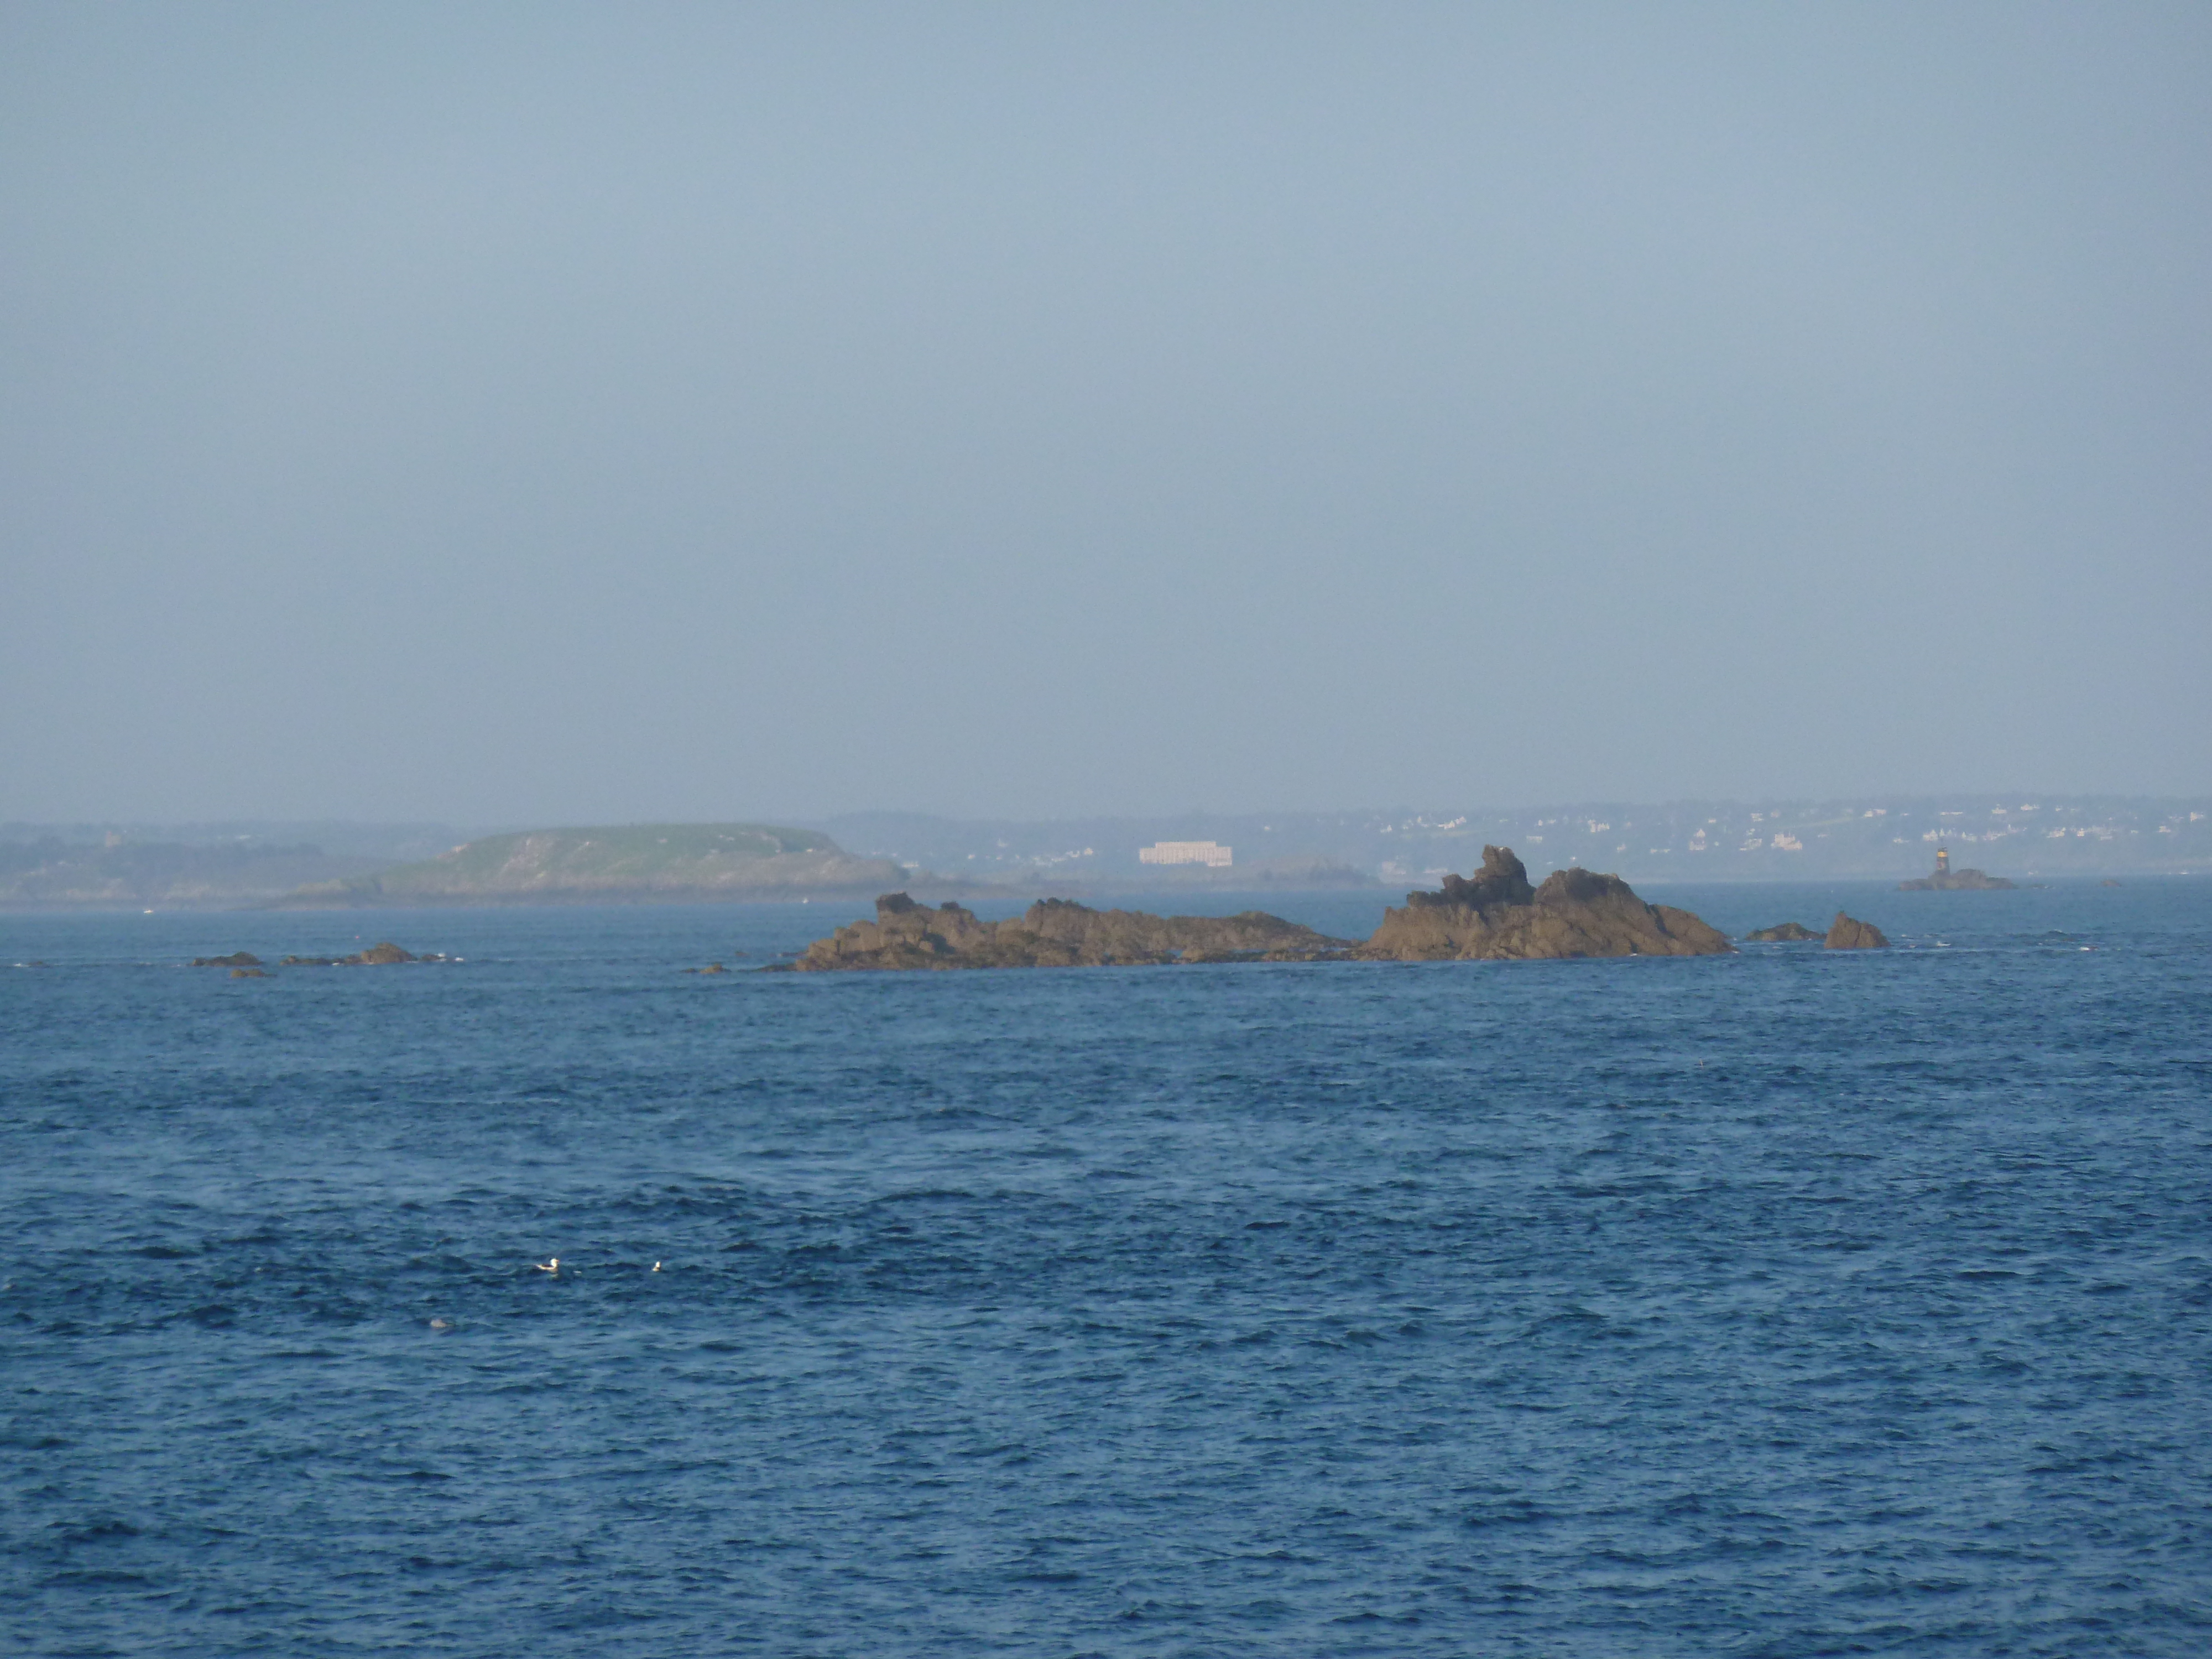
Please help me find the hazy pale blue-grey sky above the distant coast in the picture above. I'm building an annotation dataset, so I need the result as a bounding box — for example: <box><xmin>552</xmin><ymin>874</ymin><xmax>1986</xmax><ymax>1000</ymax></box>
<box><xmin>0</xmin><ymin>0</ymin><xmax>2212</xmax><ymax>823</ymax></box>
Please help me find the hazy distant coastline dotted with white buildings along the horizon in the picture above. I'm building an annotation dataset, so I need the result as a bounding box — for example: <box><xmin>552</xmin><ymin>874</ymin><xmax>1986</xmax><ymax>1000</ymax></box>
<box><xmin>0</xmin><ymin>794</ymin><xmax>2212</xmax><ymax>911</ymax></box>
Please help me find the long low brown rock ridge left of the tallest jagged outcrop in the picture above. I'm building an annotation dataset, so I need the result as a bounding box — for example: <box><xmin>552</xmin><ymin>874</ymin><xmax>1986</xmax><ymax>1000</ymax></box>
<box><xmin>790</xmin><ymin>894</ymin><xmax>1352</xmax><ymax>973</ymax></box>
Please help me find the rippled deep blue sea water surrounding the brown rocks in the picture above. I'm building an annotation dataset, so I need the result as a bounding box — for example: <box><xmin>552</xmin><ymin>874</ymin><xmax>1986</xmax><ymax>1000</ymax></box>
<box><xmin>0</xmin><ymin>880</ymin><xmax>2212</xmax><ymax>1659</ymax></box>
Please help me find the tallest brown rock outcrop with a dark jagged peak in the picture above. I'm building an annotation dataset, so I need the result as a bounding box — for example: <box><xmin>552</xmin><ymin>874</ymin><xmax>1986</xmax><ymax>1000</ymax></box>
<box><xmin>1358</xmin><ymin>847</ymin><xmax>1734</xmax><ymax>962</ymax></box>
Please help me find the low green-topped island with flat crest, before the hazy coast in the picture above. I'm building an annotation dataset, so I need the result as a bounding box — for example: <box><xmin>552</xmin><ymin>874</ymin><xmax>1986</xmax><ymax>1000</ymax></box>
<box><xmin>283</xmin><ymin>823</ymin><xmax>911</xmax><ymax>909</ymax></box>
